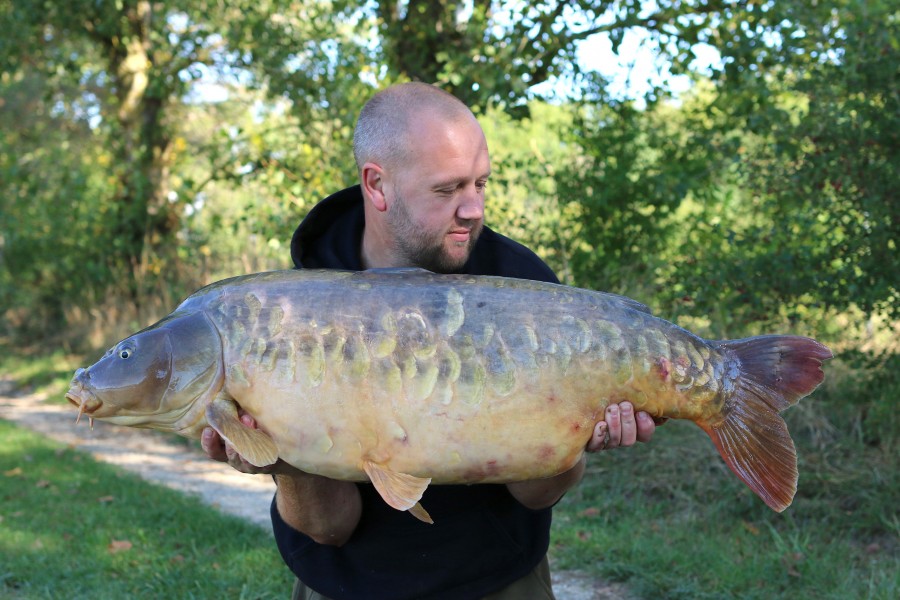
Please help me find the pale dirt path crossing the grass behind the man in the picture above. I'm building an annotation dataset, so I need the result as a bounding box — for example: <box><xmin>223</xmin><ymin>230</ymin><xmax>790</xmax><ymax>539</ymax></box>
<box><xmin>0</xmin><ymin>376</ymin><xmax>630</xmax><ymax>600</ymax></box>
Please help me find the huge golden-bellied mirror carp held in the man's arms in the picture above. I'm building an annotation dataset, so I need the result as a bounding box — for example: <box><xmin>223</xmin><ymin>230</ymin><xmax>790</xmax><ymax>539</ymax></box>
<box><xmin>66</xmin><ymin>269</ymin><xmax>831</xmax><ymax>520</ymax></box>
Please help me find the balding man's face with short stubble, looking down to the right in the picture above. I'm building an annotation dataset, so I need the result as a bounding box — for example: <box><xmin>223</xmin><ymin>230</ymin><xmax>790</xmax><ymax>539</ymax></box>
<box><xmin>385</xmin><ymin>113</ymin><xmax>491</xmax><ymax>273</ymax></box>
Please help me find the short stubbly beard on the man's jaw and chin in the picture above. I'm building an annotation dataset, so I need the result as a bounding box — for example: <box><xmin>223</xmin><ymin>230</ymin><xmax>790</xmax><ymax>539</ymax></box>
<box><xmin>387</xmin><ymin>196</ymin><xmax>482</xmax><ymax>273</ymax></box>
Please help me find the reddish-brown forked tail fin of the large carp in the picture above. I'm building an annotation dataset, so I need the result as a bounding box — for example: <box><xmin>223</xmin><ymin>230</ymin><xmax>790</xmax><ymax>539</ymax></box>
<box><xmin>699</xmin><ymin>335</ymin><xmax>832</xmax><ymax>512</ymax></box>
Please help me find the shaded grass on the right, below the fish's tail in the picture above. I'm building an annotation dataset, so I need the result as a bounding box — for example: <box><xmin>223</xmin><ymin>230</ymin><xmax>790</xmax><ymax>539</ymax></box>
<box><xmin>551</xmin><ymin>419</ymin><xmax>900</xmax><ymax>599</ymax></box>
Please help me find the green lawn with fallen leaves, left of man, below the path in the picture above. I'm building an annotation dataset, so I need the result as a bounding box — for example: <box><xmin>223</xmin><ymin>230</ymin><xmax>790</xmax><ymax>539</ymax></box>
<box><xmin>0</xmin><ymin>420</ymin><xmax>292</xmax><ymax>599</ymax></box>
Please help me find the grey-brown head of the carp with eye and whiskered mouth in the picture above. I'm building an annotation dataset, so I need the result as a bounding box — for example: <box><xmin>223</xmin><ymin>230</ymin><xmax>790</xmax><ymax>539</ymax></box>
<box><xmin>66</xmin><ymin>313</ymin><xmax>222</xmax><ymax>430</ymax></box>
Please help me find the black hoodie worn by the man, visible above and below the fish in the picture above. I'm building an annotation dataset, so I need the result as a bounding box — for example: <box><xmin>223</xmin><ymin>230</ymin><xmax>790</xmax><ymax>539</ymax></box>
<box><xmin>272</xmin><ymin>186</ymin><xmax>558</xmax><ymax>600</ymax></box>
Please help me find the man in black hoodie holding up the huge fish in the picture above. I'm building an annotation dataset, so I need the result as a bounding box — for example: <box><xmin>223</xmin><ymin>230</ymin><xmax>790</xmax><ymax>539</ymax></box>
<box><xmin>202</xmin><ymin>83</ymin><xmax>654</xmax><ymax>600</ymax></box>
